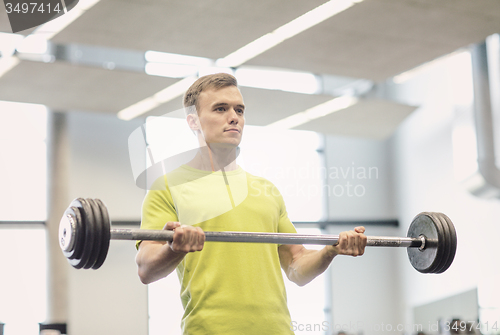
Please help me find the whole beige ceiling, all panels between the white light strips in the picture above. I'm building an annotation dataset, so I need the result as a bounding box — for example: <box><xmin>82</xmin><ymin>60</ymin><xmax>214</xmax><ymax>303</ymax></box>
<box><xmin>0</xmin><ymin>0</ymin><xmax>500</xmax><ymax>138</ymax></box>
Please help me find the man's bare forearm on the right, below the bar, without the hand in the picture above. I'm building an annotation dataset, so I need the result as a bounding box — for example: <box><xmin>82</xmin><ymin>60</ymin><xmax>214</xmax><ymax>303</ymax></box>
<box><xmin>287</xmin><ymin>246</ymin><xmax>337</xmax><ymax>286</ymax></box>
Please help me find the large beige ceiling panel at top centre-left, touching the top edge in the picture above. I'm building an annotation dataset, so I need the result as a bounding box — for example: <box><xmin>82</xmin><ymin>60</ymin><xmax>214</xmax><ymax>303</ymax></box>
<box><xmin>49</xmin><ymin>0</ymin><xmax>324</xmax><ymax>59</ymax></box>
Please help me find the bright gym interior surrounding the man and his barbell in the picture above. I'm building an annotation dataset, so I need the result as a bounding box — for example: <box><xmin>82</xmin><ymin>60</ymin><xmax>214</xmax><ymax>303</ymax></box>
<box><xmin>0</xmin><ymin>0</ymin><xmax>500</xmax><ymax>335</ymax></box>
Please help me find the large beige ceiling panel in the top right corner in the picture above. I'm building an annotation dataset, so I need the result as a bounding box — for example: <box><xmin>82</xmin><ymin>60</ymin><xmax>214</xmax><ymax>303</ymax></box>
<box><xmin>249</xmin><ymin>0</ymin><xmax>500</xmax><ymax>81</ymax></box>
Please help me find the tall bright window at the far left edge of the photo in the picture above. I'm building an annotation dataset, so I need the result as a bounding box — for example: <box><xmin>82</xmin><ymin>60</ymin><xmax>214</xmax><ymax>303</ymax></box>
<box><xmin>0</xmin><ymin>101</ymin><xmax>47</xmax><ymax>335</ymax></box>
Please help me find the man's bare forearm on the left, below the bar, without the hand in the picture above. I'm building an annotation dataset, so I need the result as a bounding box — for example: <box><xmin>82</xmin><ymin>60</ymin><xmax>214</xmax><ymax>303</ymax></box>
<box><xmin>136</xmin><ymin>242</ymin><xmax>186</xmax><ymax>284</ymax></box>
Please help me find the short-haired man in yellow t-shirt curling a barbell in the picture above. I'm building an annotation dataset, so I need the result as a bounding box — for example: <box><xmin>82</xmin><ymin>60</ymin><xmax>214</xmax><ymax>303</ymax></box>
<box><xmin>137</xmin><ymin>73</ymin><xmax>366</xmax><ymax>335</ymax></box>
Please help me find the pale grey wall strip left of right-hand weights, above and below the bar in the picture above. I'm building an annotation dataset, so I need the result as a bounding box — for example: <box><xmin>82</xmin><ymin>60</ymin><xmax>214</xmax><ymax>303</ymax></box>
<box><xmin>325</xmin><ymin>136</ymin><xmax>402</xmax><ymax>335</ymax></box>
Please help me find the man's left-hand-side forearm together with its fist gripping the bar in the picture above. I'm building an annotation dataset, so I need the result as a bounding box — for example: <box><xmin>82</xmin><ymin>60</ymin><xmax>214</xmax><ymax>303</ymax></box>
<box><xmin>136</xmin><ymin>222</ymin><xmax>205</xmax><ymax>284</ymax></box>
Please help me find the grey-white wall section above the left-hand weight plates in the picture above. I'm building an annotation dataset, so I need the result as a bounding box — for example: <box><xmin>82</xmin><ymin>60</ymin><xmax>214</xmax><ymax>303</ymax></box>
<box><xmin>68</xmin><ymin>113</ymin><xmax>145</xmax><ymax>221</ymax></box>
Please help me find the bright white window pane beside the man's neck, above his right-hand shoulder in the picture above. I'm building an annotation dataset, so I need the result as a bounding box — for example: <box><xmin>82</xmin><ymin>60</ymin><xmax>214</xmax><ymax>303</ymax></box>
<box><xmin>238</xmin><ymin>126</ymin><xmax>325</xmax><ymax>222</ymax></box>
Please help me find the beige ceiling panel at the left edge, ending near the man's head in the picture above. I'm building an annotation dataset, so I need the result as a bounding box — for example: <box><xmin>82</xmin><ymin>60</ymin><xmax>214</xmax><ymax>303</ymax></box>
<box><xmin>0</xmin><ymin>61</ymin><xmax>176</xmax><ymax>113</ymax></box>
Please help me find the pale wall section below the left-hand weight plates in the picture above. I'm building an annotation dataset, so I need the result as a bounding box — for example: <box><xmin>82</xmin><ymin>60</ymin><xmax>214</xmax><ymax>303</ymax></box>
<box><xmin>68</xmin><ymin>241</ymin><xmax>148</xmax><ymax>335</ymax></box>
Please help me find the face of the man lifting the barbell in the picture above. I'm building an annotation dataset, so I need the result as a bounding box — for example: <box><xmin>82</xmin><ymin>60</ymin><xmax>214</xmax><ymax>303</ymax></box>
<box><xmin>192</xmin><ymin>86</ymin><xmax>245</xmax><ymax>147</ymax></box>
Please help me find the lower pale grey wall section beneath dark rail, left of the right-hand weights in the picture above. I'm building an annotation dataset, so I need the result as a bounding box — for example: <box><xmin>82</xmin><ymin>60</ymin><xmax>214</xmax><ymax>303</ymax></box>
<box><xmin>330</xmin><ymin>226</ymin><xmax>406</xmax><ymax>335</ymax></box>
